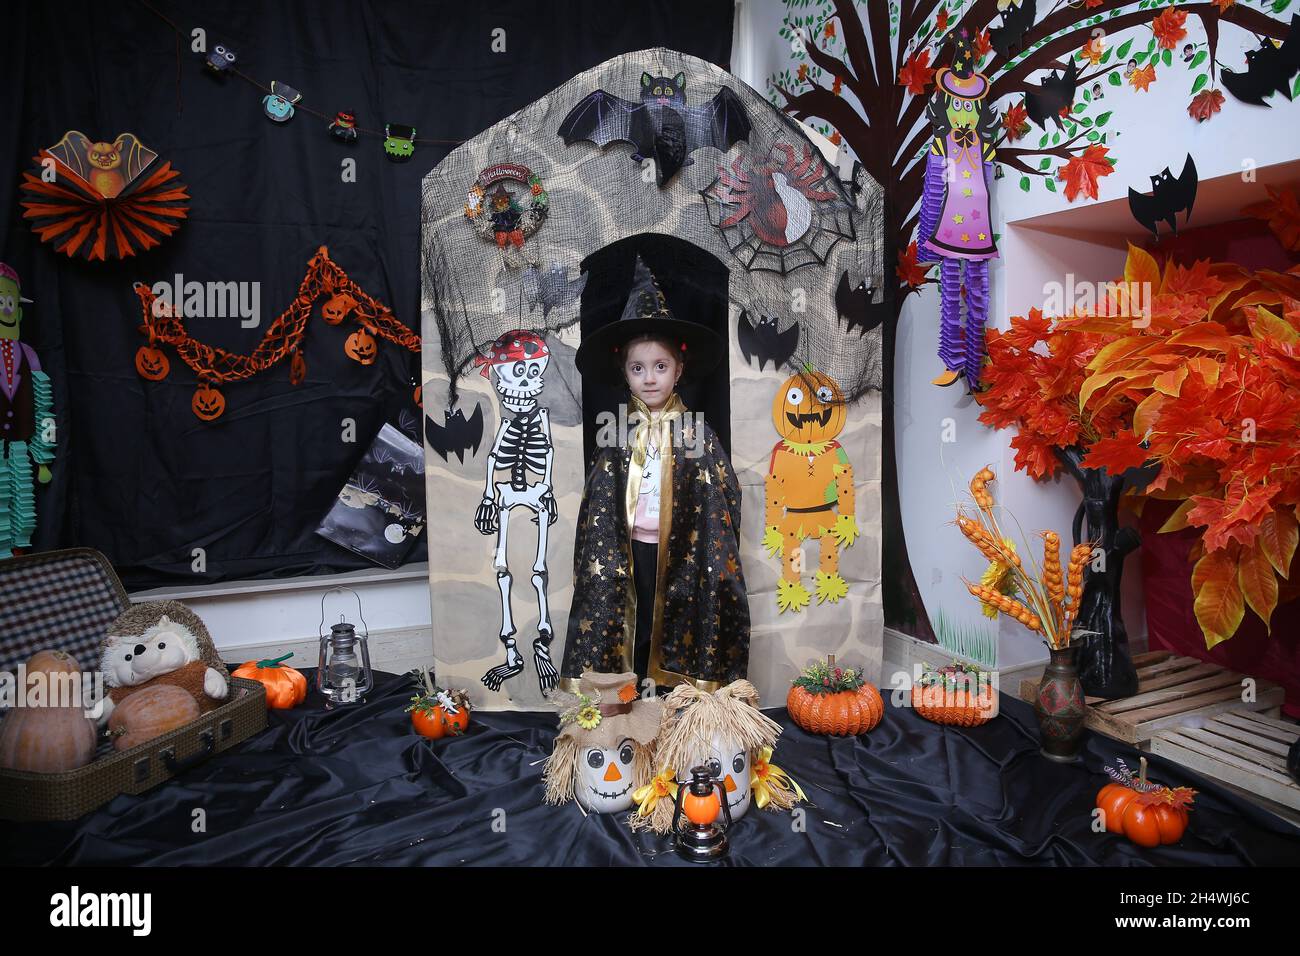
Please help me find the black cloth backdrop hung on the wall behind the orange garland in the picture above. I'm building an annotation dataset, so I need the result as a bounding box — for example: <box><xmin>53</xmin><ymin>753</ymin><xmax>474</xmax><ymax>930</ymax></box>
<box><xmin>0</xmin><ymin>0</ymin><xmax>732</xmax><ymax>588</ymax></box>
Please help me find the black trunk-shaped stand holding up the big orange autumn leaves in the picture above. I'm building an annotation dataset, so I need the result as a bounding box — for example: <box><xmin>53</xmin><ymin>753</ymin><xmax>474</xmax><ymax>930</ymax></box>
<box><xmin>1056</xmin><ymin>446</ymin><xmax>1158</xmax><ymax>700</ymax></box>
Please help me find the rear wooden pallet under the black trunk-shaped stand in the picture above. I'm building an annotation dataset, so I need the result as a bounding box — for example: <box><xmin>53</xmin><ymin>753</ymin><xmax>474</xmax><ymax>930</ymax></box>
<box><xmin>1021</xmin><ymin>650</ymin><xmax>1286</xmax><ymax>750</ymax></box>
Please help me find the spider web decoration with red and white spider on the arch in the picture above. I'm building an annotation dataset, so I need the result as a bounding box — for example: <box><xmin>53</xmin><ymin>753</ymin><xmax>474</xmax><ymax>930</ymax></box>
<box><xmin>699</xmin><ymin>142</ymin><xmax>857</xmax><ymax>276</ymax></box>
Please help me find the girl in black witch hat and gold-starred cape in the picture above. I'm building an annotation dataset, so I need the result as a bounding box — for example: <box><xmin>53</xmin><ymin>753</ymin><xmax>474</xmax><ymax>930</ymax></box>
<box><xmin>560</xmin><ymin>256</ymin><xmax>749</xmax><ymax>689</ymax></box>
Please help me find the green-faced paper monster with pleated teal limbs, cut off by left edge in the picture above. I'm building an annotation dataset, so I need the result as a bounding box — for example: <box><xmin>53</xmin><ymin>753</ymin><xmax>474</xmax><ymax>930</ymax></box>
<box><xmin>0</xmin><ymin>263</ymin><xmax>55</xmax><ymax>558</ymax></box>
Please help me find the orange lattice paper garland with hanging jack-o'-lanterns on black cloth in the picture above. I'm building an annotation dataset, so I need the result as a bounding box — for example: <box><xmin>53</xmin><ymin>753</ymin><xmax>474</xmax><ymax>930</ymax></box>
<box><xmin>135</xmin><ymin>246</ymin><xmax>420</xmax><ymax>421</ymax></box>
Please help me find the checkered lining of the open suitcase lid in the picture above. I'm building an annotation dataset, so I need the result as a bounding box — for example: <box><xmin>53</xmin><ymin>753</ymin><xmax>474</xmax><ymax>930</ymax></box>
<box><xmin>0</xmin><ymin>555</ymin><xmax>126</xmax><ymax>674</ymax></box>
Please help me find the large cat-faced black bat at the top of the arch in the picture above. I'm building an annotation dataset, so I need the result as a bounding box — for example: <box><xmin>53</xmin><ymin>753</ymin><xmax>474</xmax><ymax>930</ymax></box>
<box><xmin>559</xmin><ymin>73</ymin><xmax>751</xmax><ymax>187</ymax></box>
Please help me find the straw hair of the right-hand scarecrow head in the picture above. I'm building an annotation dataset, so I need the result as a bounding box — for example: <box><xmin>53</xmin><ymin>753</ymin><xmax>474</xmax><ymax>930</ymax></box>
<box><xmin>631</xmin><ymin>680</ymin><xmax>794</xmax><ymax>834</ymax></box>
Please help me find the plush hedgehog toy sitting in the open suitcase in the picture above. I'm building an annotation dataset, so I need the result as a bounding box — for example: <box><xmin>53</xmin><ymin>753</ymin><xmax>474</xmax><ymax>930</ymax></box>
<box><xmin>99</xmin><ymin>601</ymin><xmax>230</xmax><ymax>722</ymax></box>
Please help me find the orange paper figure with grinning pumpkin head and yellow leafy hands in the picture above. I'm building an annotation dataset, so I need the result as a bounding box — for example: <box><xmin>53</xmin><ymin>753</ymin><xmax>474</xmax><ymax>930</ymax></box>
<box><xmin>763</xmin><ymin>369</ymin><xmax>858</xmax><ymax>613</ymax></box>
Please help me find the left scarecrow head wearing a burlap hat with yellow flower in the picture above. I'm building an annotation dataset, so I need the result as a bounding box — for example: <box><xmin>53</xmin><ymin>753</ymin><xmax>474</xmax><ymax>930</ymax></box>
<box><xmin>542</xmin><ymin>671</ymin><xmax>663</xmax><ymax>813</ymax></box>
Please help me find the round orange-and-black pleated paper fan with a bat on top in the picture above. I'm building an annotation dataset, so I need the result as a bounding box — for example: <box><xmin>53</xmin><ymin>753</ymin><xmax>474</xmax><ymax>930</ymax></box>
<box><xmin>21</xmin><ymin>130</ymin><xmax>190</xmax><ymax>261</ymax></box>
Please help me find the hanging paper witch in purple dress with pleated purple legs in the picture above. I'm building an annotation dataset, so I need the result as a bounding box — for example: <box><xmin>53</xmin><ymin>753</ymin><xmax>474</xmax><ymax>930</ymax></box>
<box><xmin>917</xmin><ymin>35</ymin><xmax>997</xmax><ymax>390</ymax></box>
